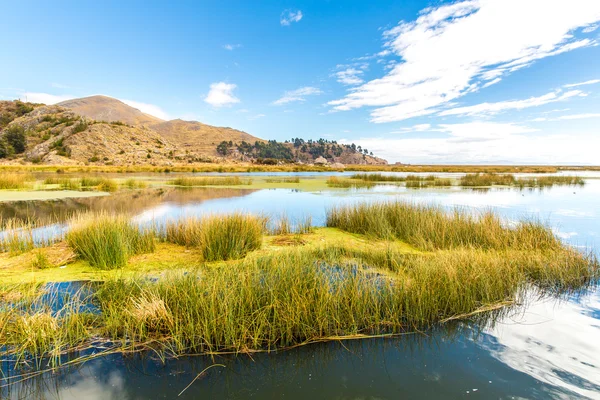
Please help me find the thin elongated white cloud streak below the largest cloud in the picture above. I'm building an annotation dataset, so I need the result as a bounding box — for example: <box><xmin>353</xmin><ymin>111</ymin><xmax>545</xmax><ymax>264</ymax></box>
<box><xmin>439</xmin><ymin>90</ymin><xmax>585</xmax><ymax>116</ymax></box>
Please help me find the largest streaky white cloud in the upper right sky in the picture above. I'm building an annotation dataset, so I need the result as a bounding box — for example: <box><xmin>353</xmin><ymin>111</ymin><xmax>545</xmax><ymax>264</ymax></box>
<box><xmin>329</xmin><ymin>0</ymin><xmax>600</xmax><ymax>123</ymax></box>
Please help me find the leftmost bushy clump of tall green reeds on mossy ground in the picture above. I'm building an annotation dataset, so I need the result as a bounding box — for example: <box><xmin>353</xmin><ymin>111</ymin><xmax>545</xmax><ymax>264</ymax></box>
<box><xmin>66</xmin><ymin>214</ymin><xmax>155</xmax><ymax>269</ymax></box>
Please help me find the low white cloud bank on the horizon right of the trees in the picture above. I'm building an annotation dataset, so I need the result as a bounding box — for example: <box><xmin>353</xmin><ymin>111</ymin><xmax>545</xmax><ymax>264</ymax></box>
<box><xmin>342</xmin><ymin>122</ymin><xmax>600</xmax><ymax>165</ymax></box>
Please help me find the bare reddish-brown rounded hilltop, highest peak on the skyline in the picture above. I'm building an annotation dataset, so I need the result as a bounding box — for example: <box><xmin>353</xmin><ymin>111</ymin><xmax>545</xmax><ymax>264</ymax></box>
<box><xmin>57</xmin><ymin>96</ymin><xmax>163</xmax><ymax>126</ymax></box>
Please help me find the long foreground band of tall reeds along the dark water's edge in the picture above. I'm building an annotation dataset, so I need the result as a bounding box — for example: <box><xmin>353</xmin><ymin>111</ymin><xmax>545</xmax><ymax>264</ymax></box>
<box><xmin>0</xmin><ymin>245</ymin><xmax>600</xmax><ymax>357</ymax></box>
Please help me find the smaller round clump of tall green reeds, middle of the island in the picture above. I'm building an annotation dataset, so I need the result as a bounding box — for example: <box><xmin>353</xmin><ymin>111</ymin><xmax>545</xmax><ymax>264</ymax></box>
<box><xmin>165</xmin><ymin>213</ymin><xmax>266</xmax><ymax>261</ymax></box>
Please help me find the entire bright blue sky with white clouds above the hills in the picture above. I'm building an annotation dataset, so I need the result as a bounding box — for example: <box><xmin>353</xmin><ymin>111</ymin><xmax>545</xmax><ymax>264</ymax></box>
<box><xmin>0</xmin><ymin>0</ymin><xmax>600</xmax><ymax>165</ymax></box>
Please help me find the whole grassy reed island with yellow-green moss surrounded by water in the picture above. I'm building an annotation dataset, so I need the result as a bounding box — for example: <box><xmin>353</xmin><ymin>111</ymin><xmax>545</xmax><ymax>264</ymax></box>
<box><xmin>0</xmin><ymin>202</ymin><xmax>600</xmax><ymax>366</ymax></box>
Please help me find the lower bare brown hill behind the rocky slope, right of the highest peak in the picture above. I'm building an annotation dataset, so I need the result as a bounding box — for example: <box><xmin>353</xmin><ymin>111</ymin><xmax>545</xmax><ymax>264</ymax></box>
<box><xmin>150</xmin><ymin>119</ymin><xmax>264</xmax><ymax>157</ymax></box>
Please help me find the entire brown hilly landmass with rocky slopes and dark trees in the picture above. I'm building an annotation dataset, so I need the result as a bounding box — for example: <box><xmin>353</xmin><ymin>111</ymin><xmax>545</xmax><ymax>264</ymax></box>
<box><xmin>0</xmin><ymin>96</ymin><xmax>387</xmax><ymax>165</ymax></box>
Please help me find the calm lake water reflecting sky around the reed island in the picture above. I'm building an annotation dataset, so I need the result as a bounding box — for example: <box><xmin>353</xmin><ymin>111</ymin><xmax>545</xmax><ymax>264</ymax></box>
<box><xmin>0</xmin><ymin>173</ymin><xmax>600</xmax><ymax>399</ymax></box>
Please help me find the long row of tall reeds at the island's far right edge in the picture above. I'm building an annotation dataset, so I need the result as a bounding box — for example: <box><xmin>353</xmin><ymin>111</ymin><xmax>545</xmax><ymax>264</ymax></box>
<box><xmin>327</xmin><ymin>202</ymin><xmax>561</xmax><ymax>250</ymax></box>
